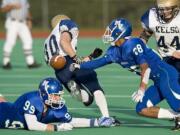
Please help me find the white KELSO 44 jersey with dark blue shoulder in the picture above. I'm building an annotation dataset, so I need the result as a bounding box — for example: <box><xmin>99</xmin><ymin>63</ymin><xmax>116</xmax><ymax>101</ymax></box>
<box><xmin>141</xmin><ymin>8</ymin><xmax>180</xmax><ymax>57</ymax></box>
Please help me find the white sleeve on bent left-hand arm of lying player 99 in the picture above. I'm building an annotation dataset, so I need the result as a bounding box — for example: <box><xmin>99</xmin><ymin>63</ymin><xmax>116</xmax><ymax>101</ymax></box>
<box><xmin>24</xmin><ymin>114</ymin><xmax>47</xmax><ymax>131</ymax></box>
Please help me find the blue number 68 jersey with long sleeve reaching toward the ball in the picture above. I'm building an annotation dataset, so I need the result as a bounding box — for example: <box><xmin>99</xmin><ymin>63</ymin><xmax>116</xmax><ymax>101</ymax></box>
<box><xmin>80</xmin><ymin>37</ymin><xmax>179</xmax><ymax>79</ymax></box>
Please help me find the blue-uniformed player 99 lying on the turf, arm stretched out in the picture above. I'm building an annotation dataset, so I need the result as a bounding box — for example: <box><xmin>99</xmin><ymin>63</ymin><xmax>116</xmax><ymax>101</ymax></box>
<box><xmin>0</xmin><ymin>78</ymin><xmax>114</xmax><ymax>131</ymax></box>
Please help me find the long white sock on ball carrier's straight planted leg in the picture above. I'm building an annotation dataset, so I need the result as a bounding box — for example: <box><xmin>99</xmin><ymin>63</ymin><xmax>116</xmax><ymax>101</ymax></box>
<box><xmin>94</xmin><ymin>90</ymin><xmax>109</xmax><ymax>117</ymax></box>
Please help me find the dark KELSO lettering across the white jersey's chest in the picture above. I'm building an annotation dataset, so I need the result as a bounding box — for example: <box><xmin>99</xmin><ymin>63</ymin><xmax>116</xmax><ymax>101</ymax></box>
<box><xmin>156</xmin><ymin>26</ymin><xmax>180</xmax><ymax>33</ymax></box>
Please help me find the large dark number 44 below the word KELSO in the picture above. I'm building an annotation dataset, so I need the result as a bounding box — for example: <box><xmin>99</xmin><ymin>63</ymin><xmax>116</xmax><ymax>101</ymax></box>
<box><xmin>158</xmin><ymin>36</ymin><xmax>180</xmax><ymax>48</ymax></box>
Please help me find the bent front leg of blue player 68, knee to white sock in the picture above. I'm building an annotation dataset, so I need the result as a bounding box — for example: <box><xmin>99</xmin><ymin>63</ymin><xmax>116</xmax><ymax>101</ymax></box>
<box><xmin>136</xmin><ymin>86</ymin><xmax>176</xmax><ymax>119</ymax></box>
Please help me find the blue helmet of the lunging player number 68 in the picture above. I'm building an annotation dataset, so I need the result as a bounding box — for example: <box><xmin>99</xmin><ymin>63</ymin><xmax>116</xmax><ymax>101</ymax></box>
<box><xmin>103</xmin><ymin>18</ymin><xmax>132</xmax><ymax>45</ymax></box>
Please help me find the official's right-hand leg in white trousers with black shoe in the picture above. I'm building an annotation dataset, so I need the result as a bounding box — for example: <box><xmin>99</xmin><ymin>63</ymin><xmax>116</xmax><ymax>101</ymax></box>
<box><xmin>19</xmin><ymin>23</ymin><xmax>40</xmax><ymax>68</ymax></box>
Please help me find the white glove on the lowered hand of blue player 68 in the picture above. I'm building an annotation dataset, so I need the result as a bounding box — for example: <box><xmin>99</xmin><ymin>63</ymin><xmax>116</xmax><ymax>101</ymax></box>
<box><xmin>131</xmin><ymin>89</ymin><xmax>144</xmax><ymax>102</ymax></box>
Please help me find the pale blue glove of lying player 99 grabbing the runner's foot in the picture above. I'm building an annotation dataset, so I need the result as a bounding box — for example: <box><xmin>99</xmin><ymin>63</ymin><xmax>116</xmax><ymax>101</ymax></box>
<box><xmin>98</xmin><ymin>117</ymin><xmax>114</xmax><ymax>127</ymax></box>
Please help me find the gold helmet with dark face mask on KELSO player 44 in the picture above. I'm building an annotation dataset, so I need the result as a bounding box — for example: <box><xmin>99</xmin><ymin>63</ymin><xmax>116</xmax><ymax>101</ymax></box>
<box><xmin>156</xmin><ymin>0</ymin><xmax>180</xmax><ymax>23</ymax></box>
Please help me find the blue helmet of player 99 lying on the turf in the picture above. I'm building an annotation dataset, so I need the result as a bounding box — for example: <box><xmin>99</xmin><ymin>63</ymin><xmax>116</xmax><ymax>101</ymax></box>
<box><xmin>39</xmin><ymin>78</ymin><xmax>65</xmax><ymax>109</ymax></box>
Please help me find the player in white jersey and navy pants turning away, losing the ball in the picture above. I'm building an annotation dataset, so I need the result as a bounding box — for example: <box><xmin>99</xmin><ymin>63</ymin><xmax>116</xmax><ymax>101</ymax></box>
<box><xmin>44</xmin><ymin>15</ymin><xmax>116</xmax><ymax>123</ymax></box>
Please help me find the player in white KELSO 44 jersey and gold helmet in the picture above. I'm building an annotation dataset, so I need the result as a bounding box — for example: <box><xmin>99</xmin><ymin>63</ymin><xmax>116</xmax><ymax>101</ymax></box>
<box><xmin>140</xmin><ymin>0</ymin><xmax>180</xmax><ymax>76</ymax></box>
